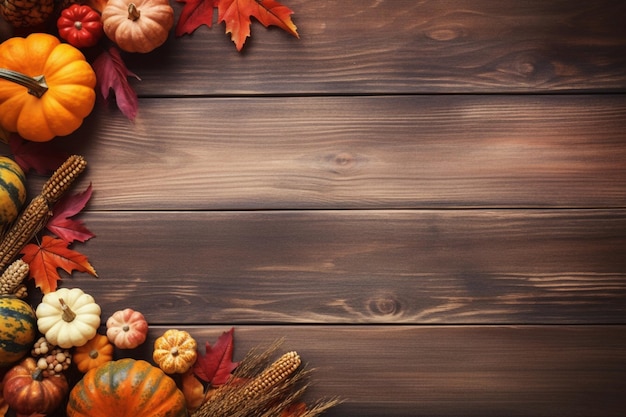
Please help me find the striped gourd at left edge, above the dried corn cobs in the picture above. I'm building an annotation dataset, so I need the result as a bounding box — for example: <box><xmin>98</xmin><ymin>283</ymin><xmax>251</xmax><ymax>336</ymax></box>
<box><xmin>0</xmin><ymin>156</ymin><xmax>26</xmax><ymax>227</ymax></box>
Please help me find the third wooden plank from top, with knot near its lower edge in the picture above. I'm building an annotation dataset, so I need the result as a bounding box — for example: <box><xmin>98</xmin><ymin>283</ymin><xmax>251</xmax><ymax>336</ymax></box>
<box><xmin>51</xmin><ymin>210</ymin><xmax>626</xmax><ymax>324</ymax></box>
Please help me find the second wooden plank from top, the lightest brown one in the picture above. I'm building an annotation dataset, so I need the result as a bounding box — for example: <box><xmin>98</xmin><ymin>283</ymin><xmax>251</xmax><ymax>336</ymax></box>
<box><xmin>18</xmin><ymin>95</ymin><xmax>626</xmax><ymax>210</ymax></box>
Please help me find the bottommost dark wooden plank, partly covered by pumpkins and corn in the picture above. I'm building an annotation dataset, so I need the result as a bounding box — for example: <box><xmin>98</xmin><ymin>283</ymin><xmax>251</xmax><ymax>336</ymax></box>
<box><xmin>42</xmin><ymin>326</ymin><xmax>626</xmax><ymax>417</ymax></box>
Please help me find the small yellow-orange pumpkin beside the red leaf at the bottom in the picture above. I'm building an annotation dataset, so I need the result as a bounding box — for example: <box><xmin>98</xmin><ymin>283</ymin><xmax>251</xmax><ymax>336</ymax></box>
<box><xmin>152</xmin><ymin>329</ymin><xmax>198</xmax><ymax>374</ymax></box>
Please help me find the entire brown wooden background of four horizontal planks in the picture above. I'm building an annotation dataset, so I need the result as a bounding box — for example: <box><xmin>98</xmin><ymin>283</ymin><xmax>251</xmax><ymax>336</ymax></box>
<box><xmin>1</xmin><ymin>0</ymin><xmax>626</xmax><ymax>417</ymax></box>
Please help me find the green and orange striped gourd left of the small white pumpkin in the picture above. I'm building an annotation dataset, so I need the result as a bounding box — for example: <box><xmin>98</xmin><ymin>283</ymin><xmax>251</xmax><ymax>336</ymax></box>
<box><xmin>0</xmin><ymin>295</ymin><xmax>37</xmax><ymax>368</ymax></box>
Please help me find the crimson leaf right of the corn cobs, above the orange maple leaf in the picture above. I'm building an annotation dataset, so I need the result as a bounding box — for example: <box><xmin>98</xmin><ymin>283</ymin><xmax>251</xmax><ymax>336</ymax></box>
<box><xmin>46</xmin><ymin>184</ymin><xmax>95</xmax><ymax>243</ymax></box>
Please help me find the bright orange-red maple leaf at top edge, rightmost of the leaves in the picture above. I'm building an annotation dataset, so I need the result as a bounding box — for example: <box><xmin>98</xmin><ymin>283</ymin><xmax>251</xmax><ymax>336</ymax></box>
<box><xmin>218</xmin><ymin>0</ymin><xmax>299</xmax><ymax>51</ymax></box>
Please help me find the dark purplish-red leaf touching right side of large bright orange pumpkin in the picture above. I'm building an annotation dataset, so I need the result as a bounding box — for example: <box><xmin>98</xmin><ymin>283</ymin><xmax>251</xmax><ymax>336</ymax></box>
<box><xmin>93</xmin><ymin>47</ymin><xmax>140</xmax><ymax>120</ymax></box>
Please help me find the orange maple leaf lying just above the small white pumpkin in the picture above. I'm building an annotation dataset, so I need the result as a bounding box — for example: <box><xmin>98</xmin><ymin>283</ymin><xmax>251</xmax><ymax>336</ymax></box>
<box><xmin>22</xmin><ymin>235</ymin><xmax>98</xmax><ymax>294</ymax></box>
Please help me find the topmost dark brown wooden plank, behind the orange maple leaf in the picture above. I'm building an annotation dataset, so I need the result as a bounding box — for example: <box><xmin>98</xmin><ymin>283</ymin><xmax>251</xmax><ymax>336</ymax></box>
<box><xmin>111</xmin><ymin>0</ymin><xmax>626</xmax><ymax>96</ymax></box>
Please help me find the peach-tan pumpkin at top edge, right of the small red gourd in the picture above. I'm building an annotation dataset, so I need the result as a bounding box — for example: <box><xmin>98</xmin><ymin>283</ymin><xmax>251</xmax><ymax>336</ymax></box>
<box><xmin>102</xmin><ymin>0</ymin><xmax>174</xmax><ymax>53</ymax></box>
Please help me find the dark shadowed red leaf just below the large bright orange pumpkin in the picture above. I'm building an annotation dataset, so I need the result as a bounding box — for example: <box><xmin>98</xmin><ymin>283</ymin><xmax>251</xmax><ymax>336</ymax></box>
<box><xmin>9</xmin><ymin>133</ymin><xmax>69</xmax><ymax>175</ymax></box>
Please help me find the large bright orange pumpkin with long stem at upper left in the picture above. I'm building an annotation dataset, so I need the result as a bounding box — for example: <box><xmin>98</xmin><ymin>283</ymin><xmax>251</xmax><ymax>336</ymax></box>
<box><xmin>0</xmin><ymin>33</ymin><xmax>96</xmax><ymax>142</ymax></box>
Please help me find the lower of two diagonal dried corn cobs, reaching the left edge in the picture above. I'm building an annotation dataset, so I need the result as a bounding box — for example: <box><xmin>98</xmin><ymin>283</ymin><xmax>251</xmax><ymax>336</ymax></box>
<box><xmin>0</xmin><ymin>195</ymin><xmax>51</xmax><ymax>270</ymax></box>
